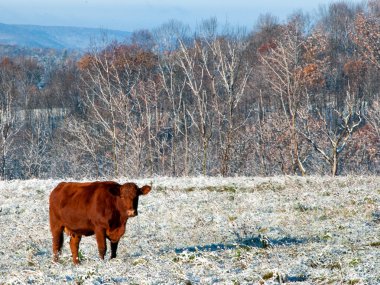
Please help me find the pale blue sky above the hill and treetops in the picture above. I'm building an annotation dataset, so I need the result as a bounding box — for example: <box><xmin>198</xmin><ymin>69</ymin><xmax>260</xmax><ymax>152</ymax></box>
<box><xmin>0</xmin><ymin>0</ymin><xmax>361</xmax><ymax>32</ymax></box>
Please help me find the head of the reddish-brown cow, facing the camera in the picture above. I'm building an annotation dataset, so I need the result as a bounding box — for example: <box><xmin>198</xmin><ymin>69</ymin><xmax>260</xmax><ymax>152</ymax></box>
<box><xmin>120</xmin><ymin>183</ymin><xmax>151</xmax><ymax>217</ymax></box>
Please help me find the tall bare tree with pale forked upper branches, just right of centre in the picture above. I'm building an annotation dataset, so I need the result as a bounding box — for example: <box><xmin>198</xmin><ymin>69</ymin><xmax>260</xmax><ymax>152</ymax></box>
<box><xmin>202</xmin><ymin>28</ymin><xmax>252</xmax><ymax>176</ymax></box>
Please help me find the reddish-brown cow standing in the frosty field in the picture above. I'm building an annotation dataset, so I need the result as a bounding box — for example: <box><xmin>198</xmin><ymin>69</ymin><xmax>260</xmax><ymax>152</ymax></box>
<box><xmin>49</xmin><ymin>181</ymin><xmax>151</xmax><ymax>264</ymax></box>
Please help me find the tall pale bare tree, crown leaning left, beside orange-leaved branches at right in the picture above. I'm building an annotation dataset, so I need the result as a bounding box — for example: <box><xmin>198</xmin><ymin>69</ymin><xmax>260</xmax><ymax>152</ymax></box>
<box><xmin>261</xmin><ymin>22</ymin><xmax>306</xmax><ymax>175</ymax></box>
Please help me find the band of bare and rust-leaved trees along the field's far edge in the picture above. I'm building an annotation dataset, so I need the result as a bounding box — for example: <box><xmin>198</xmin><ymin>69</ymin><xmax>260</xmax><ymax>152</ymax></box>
<box><xmin>0</xmin><ymin>1</ymin><xmax>380</xmax><ymax>179</ymax></box>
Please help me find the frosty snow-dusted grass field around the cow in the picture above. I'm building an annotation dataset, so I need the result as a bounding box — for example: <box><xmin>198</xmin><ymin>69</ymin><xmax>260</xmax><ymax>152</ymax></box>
<box><xmin>0</xmin><ymin>176</ymin><xmax>380</xmax><ymax>284</ymax></box>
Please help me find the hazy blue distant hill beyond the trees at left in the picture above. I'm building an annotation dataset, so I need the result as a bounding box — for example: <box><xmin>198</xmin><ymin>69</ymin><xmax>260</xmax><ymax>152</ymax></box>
<box><xmin>0</xmin><ymin>23</ymin><xmax>131</xmax><ymax>50</ymax></box>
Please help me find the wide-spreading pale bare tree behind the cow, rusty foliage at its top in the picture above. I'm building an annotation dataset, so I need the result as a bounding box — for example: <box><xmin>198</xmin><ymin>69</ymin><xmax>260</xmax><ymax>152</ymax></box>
<box><xmin>77</xmin><ymin>42</ymin><xmax>156</xmax><ymax>176</ymax></box>
